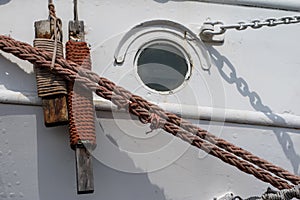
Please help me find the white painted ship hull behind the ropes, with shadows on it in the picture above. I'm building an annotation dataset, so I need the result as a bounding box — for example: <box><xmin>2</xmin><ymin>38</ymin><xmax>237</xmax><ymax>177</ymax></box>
<box><xmin>0</xmin><ymin>0</ymin><xmax>300</xmax><ymax>200</ymax></box>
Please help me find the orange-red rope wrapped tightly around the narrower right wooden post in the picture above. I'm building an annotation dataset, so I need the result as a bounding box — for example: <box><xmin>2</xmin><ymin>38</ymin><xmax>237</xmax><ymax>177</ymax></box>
<box><xmin>66</xmin><ymin>41</ymin><xmax>96</xmax><ymax>149</ymax></box>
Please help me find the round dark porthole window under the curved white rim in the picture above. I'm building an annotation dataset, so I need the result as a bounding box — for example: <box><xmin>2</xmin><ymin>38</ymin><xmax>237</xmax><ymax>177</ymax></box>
<box><xmin>137</xmin><ymin>43</ymin><xmax>189</xmax><ymax>92</ymax></box>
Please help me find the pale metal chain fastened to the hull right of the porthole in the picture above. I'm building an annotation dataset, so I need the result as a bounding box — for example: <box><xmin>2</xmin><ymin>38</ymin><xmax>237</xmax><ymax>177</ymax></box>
<box><xmin>201</xmin><ymin>15</ymin><xmax>300</xmax><ymax>35</ymax></box>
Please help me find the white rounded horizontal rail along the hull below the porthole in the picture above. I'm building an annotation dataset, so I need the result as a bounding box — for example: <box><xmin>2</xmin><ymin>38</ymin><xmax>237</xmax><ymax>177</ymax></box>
<box><xmin>0</xmin><ymin>90</ymin><xmax>300</xmax><ymax>129</ymax></box>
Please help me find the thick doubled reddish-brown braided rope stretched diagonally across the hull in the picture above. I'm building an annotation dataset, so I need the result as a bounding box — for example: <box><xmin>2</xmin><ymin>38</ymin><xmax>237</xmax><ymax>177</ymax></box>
<box><xmin>0</xmin><ymin>36</ymin><xmax>300</xmax><ymax>189</ymax></box>
